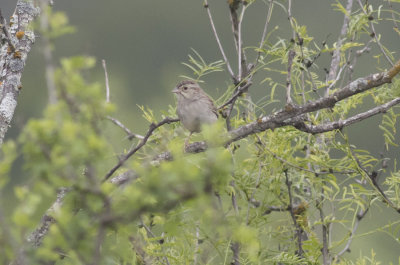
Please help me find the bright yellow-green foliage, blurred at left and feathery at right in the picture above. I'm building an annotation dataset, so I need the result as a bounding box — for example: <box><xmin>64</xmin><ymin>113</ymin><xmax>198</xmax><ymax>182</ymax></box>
<box><xmin>0</xmin><ymin>1</ymin><xmax>400</xmax><ymax>264</ymax></box>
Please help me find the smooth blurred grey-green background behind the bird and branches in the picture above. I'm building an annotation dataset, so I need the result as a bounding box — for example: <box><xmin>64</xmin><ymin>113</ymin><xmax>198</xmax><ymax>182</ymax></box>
<box><xmin>0</xmin><ymin>0</ymin><xmax>400</xmax><ymax>264</ymax></box>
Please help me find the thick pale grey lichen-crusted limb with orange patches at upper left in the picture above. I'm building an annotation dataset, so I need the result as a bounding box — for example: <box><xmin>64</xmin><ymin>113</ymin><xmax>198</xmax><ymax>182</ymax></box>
<box><xmin>0</xmin><ymin>0</ymin><xmax>39</xmax><ymax>146</ymax></box>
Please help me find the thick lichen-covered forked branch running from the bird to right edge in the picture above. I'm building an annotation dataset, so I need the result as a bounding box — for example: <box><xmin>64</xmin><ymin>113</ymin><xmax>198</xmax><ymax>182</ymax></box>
<box><xmin>154</xmin><ymin>61</ymin><xmax>400</xmax><ymax>154</ymax></box>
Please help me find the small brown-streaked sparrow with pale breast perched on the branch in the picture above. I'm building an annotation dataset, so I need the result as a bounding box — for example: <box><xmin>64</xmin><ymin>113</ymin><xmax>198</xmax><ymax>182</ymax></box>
<box><xmin>172</xmin><ymin>80</ymin><xmax>218</xmax><ymax>147</ymax></box>
